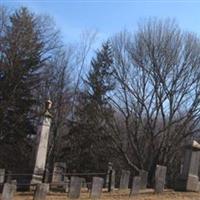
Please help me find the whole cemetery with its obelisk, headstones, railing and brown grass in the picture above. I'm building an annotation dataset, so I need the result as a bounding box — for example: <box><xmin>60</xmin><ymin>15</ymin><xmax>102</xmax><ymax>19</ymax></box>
<box><xmin>0</xmin><ymin>100</ymin><xmax>200</xmax><ymax>200</ymax></box>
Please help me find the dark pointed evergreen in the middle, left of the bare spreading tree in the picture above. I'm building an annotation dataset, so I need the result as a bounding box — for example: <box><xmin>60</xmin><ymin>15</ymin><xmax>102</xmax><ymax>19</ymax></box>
<box><xmin>63</xmin><ymin>42</ymin><xmax>115</xmax><ymax>171</ymax></box>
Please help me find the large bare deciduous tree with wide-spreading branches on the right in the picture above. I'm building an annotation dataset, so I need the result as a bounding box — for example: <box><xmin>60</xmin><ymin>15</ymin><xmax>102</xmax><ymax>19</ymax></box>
<box><xmin>110</xmin><ymin>19</ymin><xmax>200</xmax><ymax>183</ymax></box>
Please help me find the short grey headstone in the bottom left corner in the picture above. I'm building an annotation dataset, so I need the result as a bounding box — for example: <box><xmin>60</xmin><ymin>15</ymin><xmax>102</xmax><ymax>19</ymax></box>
<box><xmin>1</xmin><ymin>183</ymin><xmax>16</xmax><ymax>200</ymax></box>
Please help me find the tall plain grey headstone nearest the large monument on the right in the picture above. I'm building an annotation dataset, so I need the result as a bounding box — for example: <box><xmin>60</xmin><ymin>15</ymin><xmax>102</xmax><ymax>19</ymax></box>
<box><xmin>155</xmin><ymin>165</ymin><xmax>167</xmax><ymax>193</ymax></box>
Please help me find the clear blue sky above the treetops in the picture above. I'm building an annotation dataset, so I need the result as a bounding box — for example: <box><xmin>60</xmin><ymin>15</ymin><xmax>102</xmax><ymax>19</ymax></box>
<box><xmin>0</xmin><ymin>0</ymin><xmax>200</xmax><ymax>45</ymax></box>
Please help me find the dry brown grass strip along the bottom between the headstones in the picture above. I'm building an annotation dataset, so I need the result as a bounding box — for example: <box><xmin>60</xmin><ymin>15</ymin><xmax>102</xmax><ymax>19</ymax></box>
<box><xmin>14</xmin><ymin>190</ymin><xmax>200</xmax><ymax>200</ymax></box>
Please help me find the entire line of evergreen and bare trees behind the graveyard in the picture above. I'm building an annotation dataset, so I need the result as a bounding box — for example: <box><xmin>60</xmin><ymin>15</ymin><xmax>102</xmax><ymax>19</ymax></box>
<box><xmin>0</xmin><ymin>6</ymin><xmax>200</xmax><ymax>186</ymax></box>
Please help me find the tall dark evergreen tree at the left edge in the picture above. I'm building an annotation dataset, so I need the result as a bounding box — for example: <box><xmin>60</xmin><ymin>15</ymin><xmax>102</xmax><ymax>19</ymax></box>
<box><xmin>0</xmin><ymin>8</ymin><xmax>58</xmax><ymax>168</ymax></box>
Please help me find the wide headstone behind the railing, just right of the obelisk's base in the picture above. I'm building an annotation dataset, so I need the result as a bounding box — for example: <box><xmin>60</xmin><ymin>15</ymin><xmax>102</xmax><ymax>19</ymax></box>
<box><xmin>52</xmin><ymin>162</ymin><xmax>66</xmax><ymax>183</ymax></box>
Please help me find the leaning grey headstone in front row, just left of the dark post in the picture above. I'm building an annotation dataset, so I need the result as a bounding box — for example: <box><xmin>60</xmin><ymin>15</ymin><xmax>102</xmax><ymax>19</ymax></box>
<box><xmin>91</xmin><ymin>177</ymin><xmax>104</xmax><ymax>200</ymax></box>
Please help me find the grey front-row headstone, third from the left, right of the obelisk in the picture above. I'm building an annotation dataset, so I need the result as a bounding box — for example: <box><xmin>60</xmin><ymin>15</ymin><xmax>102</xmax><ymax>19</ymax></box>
<box><xmin>69</xmin><ymin>176</ymin><xmax>81</xmax><ymax>199</ymax></box>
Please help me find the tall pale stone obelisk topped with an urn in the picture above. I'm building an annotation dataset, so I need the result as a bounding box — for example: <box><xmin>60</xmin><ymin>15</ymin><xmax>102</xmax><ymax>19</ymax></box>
<box><xmin>31</xmin><ymin>100</ymin><xmax>52</xmax><ymax>184</ymax></box>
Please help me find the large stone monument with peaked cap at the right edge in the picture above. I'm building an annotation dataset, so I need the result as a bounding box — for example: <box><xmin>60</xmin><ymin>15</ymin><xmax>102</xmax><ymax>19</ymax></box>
<box><xmin>174</xmin><ymin>140</ymin><xmax>200</xmax><ymax>192</ymax></box>
